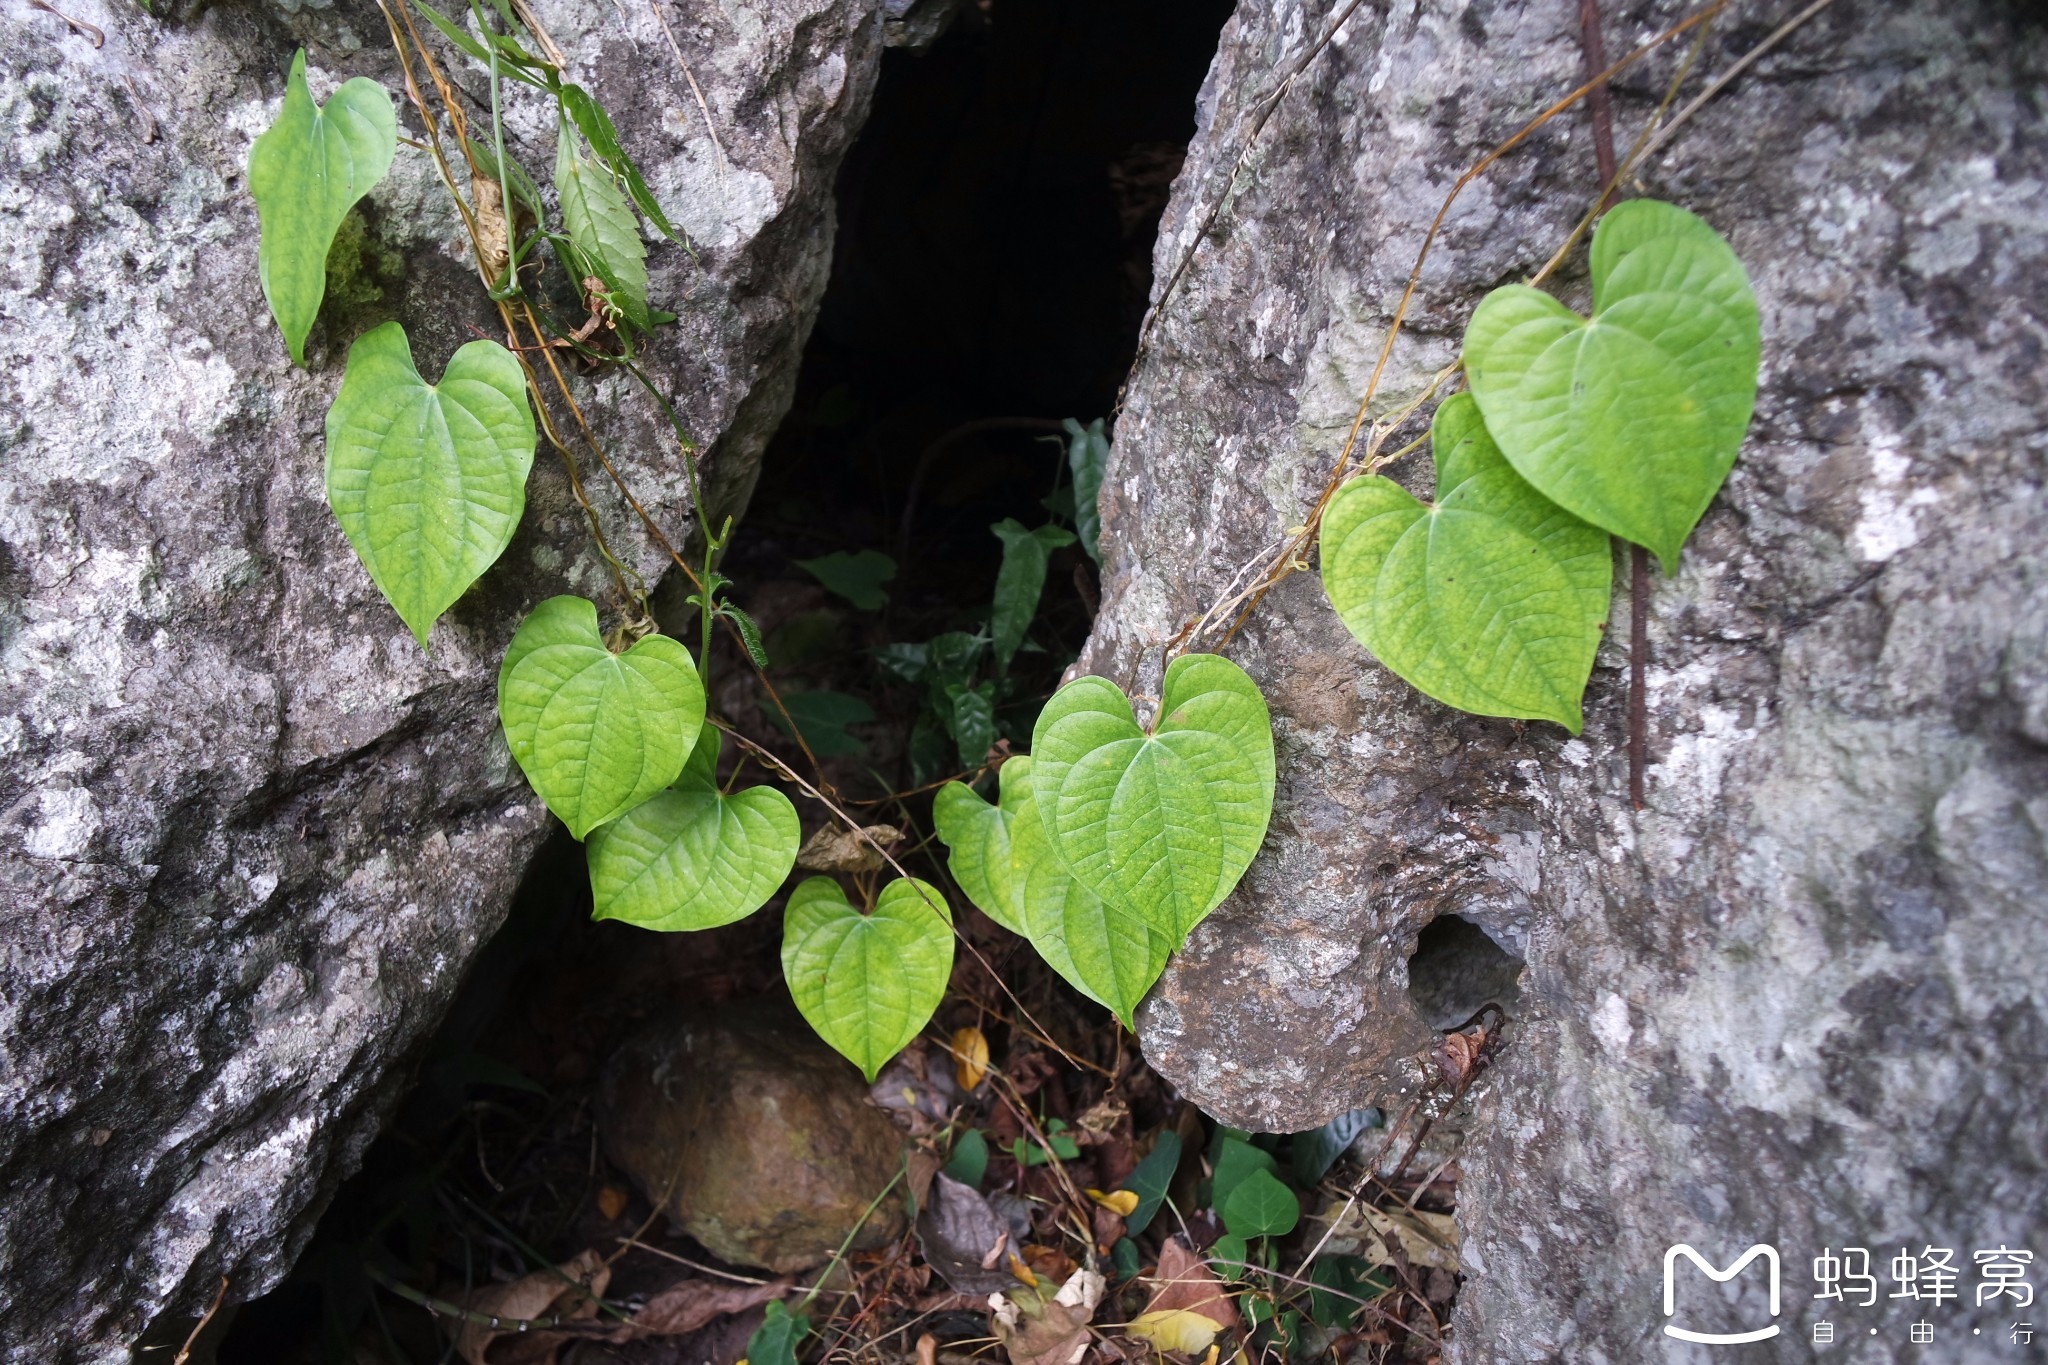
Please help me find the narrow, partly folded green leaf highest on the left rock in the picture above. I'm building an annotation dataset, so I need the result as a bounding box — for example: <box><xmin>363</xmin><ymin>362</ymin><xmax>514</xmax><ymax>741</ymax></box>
<box><xmin>250</xmin><ymin>47</ymin><xmax>397</xmax><ymax>364</ymax></box>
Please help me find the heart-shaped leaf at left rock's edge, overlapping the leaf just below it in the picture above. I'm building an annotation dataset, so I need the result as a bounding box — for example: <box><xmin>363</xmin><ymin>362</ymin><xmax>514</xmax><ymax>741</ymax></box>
<box><xmin>498</xmin><ymin>598</ymin><xmax>705</xmax><ymax>839</ymax></box>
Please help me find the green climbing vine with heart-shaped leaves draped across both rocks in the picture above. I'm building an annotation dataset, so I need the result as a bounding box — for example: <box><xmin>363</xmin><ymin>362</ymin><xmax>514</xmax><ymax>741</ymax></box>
<box><xmin>250</xmin><ymin>0</ymin><xmax>1761</xmax><ymax>1096</ymax></box>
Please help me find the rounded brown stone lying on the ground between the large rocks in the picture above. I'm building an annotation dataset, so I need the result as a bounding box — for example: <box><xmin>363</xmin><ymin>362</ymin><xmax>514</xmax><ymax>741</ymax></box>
<box><xmin>598</xmin><ymin>1003</ymin><xmax>905</xmax><ymax>1275</ymax></box>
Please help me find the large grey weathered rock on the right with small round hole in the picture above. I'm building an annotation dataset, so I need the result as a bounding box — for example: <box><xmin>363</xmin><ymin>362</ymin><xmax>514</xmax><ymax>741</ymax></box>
<box><xmin>1083</xmin><ymin>0</ymin><xmax>2048</xmax><ymax>1363</ymax></box>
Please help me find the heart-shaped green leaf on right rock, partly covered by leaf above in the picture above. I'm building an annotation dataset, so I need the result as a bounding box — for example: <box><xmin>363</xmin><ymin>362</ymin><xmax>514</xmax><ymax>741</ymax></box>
<box><xmin>1323</xmin><ymin>393</ymin><xmax>1614</xmax><ymax>735</ymax></box>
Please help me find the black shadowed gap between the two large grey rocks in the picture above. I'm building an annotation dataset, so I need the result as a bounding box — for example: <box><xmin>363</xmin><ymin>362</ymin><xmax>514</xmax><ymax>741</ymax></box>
<box><xmin>211</xmin><ymin>0</ymin><xmax>1231</xmax><ymax>1365</ymax></box>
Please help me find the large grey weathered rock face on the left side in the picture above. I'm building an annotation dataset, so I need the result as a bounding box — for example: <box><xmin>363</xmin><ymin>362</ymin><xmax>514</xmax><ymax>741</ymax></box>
<box><xmin>0</xmin><ymin>0</ymin><xmax>897</xmax><ymax>1361</ymax></box>
